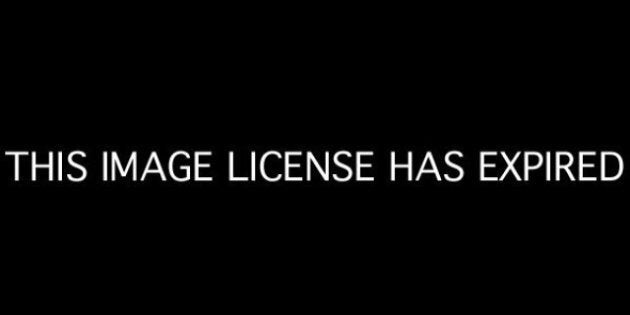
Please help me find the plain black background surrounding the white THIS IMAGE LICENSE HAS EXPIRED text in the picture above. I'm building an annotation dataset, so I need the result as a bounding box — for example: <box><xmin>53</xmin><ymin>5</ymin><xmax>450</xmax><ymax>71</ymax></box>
<box><xmin>0</xmin><ymin>4</ymin><xmax>628</xmax><ymax>308</ymax></box>
